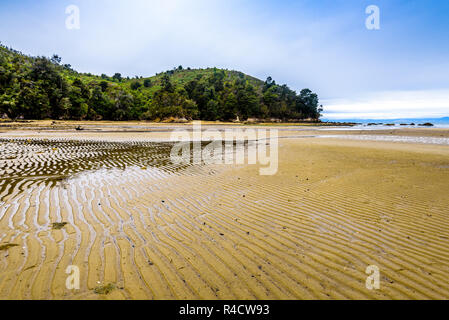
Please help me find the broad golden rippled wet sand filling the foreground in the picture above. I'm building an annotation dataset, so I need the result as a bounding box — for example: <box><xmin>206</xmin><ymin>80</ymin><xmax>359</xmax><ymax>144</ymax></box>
<box><xmin>0</xmin><ymin>125</ymin><xmax>449</xmax><ymax>299</ymax></box>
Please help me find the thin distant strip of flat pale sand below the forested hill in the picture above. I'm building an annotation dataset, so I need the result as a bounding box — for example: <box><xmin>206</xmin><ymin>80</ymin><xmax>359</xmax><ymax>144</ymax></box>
<box><xmin>0</xmin><ymin>121</ymin><xmax>449</xmax><ymax>144</ymax></box>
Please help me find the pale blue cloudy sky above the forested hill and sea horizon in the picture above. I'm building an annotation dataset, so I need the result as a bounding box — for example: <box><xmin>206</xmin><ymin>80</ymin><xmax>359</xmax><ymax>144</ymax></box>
<box><xmin>0</xmin><ymin>0</ymin><xmax>449</xmax><ymax>119</ymax></box>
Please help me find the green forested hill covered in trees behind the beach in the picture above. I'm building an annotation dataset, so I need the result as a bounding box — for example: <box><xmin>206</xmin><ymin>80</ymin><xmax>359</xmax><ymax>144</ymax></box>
<box><xmin>0</xmin><ymin>46</ymin><xmax>322</xmax><ymax>121</ymax></box>
